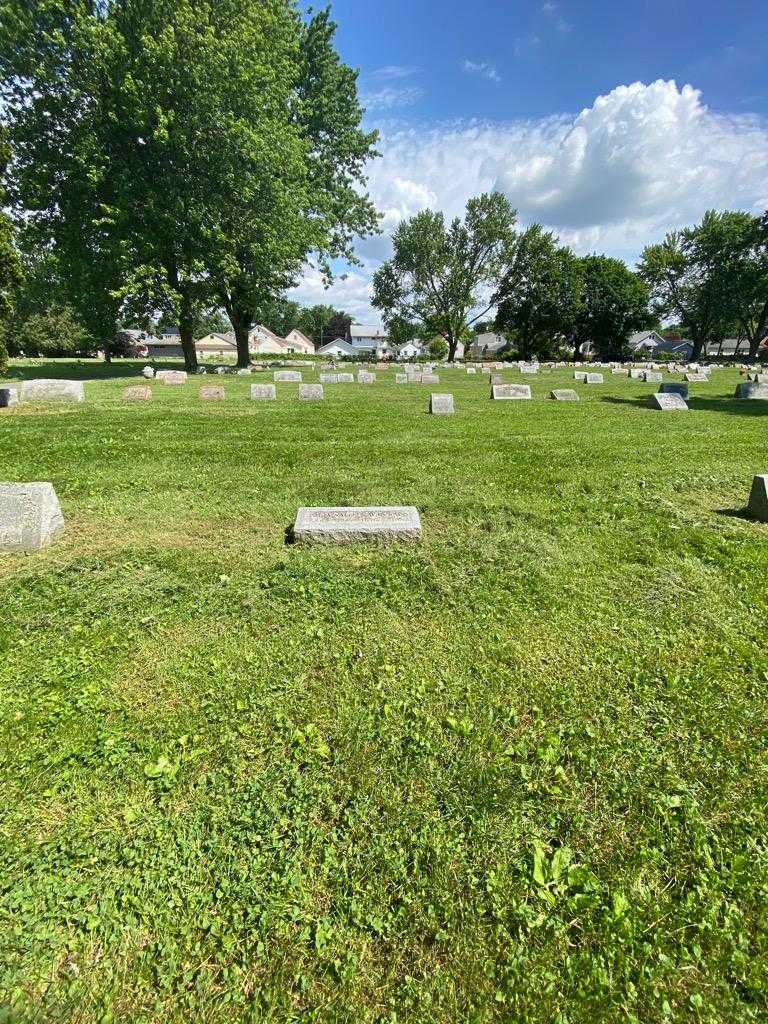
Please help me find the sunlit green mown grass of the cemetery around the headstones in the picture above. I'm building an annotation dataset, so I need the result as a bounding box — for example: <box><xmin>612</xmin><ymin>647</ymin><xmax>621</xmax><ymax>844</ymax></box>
<box><xmin>0</xmin><ymin>362</ymin><xmax>768</xmax><ymax>1024</ymax></box>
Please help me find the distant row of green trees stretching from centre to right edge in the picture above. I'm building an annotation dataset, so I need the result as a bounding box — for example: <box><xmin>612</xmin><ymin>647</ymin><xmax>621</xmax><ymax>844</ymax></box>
<box><xmin>373</xmin><ymin>194</ymin><xmax>768</xmax><ymax>358</ymax></box>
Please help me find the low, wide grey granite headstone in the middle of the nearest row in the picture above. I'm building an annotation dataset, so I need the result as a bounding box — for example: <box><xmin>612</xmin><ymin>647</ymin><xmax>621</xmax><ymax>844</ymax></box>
<box><xmin>293</xmin><ymin>505</ymin><xmax>421</xmax><ymax>544</ymax></box>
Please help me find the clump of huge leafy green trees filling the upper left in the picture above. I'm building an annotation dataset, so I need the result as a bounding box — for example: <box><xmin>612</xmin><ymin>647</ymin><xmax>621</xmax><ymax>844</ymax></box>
<box><xmin>0</xmin><ymin>0</ymin><xmax>378</xmax><ymax>369</ymax></box>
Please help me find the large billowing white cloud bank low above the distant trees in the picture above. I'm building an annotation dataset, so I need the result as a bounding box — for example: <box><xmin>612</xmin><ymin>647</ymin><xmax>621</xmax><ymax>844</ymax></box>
<box><xmin>290</xmin><ymin>81</ymin><xmax>768</xmax><ymax>323</ymax></box>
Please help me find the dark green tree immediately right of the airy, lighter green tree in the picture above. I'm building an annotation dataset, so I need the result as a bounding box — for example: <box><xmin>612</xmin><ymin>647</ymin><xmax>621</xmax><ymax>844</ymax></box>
<box><xmin>496</xmin><ymin>224</ymin><xmax>583</xmax><ymax>358</ymax></box>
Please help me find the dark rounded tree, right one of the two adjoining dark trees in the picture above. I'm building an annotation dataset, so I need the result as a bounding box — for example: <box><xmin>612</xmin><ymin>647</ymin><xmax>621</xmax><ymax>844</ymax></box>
<box><xmin>571</xmin><ymin>256</ymin><xmax>653</xmax><ymax>358</ymax></box>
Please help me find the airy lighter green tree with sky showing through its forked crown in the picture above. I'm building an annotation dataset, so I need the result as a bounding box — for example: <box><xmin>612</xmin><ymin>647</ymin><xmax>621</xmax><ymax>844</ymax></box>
<box><xmin>373</xmin><ymin>193</ymin><xmax>516</xmax><ymax>359</ymax></box>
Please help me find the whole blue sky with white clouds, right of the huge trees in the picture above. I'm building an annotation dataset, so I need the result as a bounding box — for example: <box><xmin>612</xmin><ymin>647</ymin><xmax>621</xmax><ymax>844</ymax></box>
<box><xmin>298</xmin><ymin>0</ymin><xmax>768</xmax><ymax>322</ymax></box>
